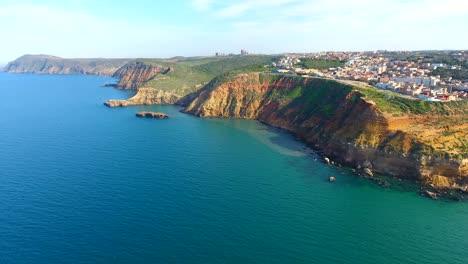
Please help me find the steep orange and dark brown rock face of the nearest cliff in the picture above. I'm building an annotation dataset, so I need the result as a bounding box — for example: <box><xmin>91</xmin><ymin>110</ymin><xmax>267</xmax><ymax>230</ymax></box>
<box><xmin>185</xmin><ymin>74</ymin><xmax>468</xmax><ymax>189</ymax></box>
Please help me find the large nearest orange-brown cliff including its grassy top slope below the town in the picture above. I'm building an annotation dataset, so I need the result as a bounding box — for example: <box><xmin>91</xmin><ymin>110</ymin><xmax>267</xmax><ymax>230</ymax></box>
<box><xmin>184</xmin><ymin>73</ymin><xmax>468</xmax><ymax>192</ymax></box>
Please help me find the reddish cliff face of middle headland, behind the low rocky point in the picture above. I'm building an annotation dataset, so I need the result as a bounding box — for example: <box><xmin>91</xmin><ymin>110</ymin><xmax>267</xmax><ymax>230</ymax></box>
<box><xmin>113</xmin><ymin>62</ymin><xmax>171</xmax><ymax>90</ymax></box>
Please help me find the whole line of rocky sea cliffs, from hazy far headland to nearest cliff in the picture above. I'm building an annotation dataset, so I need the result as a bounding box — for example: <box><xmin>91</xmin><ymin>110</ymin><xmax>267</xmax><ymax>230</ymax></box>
<box><xmin>4</xmin><ymin>55</ymin><xmax>468</xmax><ymax>199</ymax></box>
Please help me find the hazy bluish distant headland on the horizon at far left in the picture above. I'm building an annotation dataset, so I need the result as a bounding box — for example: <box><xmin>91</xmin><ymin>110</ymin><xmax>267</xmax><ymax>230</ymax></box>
<box><xmin>3</xmin><ymin>55</ymin><xmax>128</xmax><ymax>76</ymax></box>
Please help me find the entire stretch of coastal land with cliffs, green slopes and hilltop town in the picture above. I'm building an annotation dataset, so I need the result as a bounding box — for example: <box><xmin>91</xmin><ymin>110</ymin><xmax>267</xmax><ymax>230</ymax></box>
<box><xmin>3</xmin><ymin>51</ymin><xmax>468</xmax><ymax>199</ymax></box>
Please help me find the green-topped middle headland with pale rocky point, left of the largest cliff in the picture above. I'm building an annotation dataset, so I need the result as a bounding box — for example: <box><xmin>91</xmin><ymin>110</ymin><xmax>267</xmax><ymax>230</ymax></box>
<box><xmin>106</xmin><ymin>55</ymin><xmax>276</xmax><ymax>106</ymax></box>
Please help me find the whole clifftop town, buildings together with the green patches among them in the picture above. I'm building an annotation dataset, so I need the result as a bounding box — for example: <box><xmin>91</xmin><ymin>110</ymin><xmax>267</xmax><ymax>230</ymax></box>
<box><xmin>271</xmin><ymin>51</ymin><xmax>468</xmax><ymax>102</ymax></box>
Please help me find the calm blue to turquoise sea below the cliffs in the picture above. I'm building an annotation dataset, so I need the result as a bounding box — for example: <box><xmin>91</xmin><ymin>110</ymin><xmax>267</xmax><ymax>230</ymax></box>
<box><xmin>0</xmin><ymin>73</ymin><xmax>468</xmax><ymax>264</ymax></box>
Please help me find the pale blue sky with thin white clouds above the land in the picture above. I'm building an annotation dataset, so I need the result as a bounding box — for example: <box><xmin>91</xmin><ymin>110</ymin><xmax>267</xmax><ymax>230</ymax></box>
<box><xmin>0</xmin><ymin>0</ymin><xmax>468</xmax><ymax>64</ymax></box>
